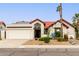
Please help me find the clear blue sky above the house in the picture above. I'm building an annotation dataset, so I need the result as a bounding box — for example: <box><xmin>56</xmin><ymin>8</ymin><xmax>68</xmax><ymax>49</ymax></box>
<box><xmin>0</xmin><ymin>3</ymin><xmax>79</xmax><ymax>24</ymax></box>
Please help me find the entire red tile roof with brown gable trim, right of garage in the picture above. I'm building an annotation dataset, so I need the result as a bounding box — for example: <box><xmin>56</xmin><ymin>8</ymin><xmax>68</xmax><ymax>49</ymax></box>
<box><xmin>30</xmin><ymin>19</ymin><xmax>73</xmax><ymax>29</ymax></box>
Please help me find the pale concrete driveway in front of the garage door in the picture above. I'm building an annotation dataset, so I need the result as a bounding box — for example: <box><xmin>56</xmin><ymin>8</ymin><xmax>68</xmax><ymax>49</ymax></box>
<box><xmin>0</xmin><ymin>39</ymin><xmax>28</xmax><ymax>48</ymax></box>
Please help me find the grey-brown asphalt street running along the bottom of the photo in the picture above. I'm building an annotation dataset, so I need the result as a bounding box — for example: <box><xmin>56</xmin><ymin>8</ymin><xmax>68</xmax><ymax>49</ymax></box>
<box><xmin>0</xmin><ymin>48</ymin><xmax>79</xmax><ymax>56</ymax></box>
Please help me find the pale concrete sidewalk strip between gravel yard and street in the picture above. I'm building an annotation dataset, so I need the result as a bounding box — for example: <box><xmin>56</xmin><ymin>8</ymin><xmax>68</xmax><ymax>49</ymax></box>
<box><xmin>17</xmin><ymin>45</ymin><xmax>79</xmax><ymax>48</ymax></box>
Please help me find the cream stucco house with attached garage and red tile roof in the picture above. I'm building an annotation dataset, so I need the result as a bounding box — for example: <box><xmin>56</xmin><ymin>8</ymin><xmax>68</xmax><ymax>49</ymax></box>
<box><xmin>1</xmin><ymin>19</ymin><xmax>76</xmax><ymax>40</ymax></box>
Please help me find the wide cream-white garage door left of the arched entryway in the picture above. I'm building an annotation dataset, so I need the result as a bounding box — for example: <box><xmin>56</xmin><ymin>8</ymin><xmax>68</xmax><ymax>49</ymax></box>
<box><xmin>6</xmin><ymin>29</ymin><xmax>33</xmax><ymax>39</ymax></box>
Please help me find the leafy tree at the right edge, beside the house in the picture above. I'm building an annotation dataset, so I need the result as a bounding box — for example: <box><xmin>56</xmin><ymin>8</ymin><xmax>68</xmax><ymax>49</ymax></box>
<box><xmin>73</xmin><ymin>13</ymin><xmax>79</xmax><ymax>38</ymax></box>
